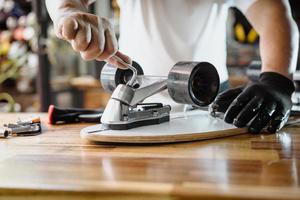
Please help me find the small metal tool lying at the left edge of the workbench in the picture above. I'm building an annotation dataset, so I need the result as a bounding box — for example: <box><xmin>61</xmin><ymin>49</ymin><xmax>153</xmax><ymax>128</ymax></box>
<box><xmin>0</xmin><ymin>117</ymin><xmax>42</xmax><ymax>138</ymax></box>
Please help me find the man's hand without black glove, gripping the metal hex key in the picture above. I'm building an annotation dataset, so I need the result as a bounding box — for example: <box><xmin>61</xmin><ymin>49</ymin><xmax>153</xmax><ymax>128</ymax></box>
<box><xmin>46</xmin><ymin>0</ymin><xmax>131</xmax><ymax>68</ymax></box>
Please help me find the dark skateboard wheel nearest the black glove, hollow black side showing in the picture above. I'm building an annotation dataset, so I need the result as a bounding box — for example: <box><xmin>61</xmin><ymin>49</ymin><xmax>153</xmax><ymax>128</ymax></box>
<box><xmin>167</xmin><ymin>62</ymin><xmax>220</xmax><ymax>106</ymax></box>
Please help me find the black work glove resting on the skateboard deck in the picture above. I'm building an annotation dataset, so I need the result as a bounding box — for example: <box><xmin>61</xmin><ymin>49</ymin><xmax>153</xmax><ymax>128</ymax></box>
<box><xmin>211</xmin><ymin>72</ymin><xmax>295</xmax><ymax>133</ymax></box>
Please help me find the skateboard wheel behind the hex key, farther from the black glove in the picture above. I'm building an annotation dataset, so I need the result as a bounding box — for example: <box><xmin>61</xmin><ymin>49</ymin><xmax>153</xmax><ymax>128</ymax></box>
<box><xmin>100</xmin><ymin>61</ymin><xmax>144</xmax><ymax>93</ymax></box>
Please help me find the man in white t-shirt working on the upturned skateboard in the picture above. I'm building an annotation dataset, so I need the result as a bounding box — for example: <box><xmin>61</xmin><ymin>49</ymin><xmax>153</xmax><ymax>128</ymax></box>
<box><xmin>46</xmin><ymin>0</ymin><xmax>299</xmax><ymax>133</ymax></box>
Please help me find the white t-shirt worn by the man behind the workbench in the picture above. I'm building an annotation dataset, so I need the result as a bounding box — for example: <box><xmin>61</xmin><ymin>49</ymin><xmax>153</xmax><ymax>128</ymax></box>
<box><xmin>118</xmin><ymin>0</ymin><xmax>255</xmax><ymax>111</ymax></box>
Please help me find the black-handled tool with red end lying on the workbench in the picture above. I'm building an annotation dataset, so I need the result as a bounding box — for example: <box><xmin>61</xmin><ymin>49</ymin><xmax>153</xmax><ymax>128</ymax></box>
<box><xmin>48</xmin><ymin>105</ymin><xmax>103</xmax><ymax>124</ymax></box>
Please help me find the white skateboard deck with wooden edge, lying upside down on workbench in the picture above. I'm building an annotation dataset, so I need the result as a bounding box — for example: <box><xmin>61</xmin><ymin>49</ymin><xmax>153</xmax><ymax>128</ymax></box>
<box><xmin>80</xmin><ymin>110</ymin><xmax>247</xmax><ymax>143</ymax></box>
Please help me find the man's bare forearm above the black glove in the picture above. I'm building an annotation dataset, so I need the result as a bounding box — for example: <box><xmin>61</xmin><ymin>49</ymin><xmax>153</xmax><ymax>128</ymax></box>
<box><xmin>246</xmin><ymin>0</ymin><xmax>299</xmax><ymax>77</ymax></box>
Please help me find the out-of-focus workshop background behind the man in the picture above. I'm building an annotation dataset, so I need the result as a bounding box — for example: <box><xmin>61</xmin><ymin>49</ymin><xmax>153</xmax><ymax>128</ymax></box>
<box><xmin>0</xmin><ymin>0</ymin><xmax>300</xmax><ymax>112</ymax></box>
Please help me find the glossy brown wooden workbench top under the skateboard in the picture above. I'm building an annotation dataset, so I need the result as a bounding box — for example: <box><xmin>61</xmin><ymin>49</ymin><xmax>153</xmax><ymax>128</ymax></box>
<box><xmin>0</xmin><ymin>113</ymin><xmax>300</xmax><ymax>200</ymax></box>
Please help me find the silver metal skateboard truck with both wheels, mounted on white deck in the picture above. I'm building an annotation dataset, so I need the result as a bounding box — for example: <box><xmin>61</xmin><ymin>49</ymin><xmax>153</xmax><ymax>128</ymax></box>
<box><xmin>100</xmin><ymin>62</ymin><xmax>219</xmax><ymax>130</ymax></box>
